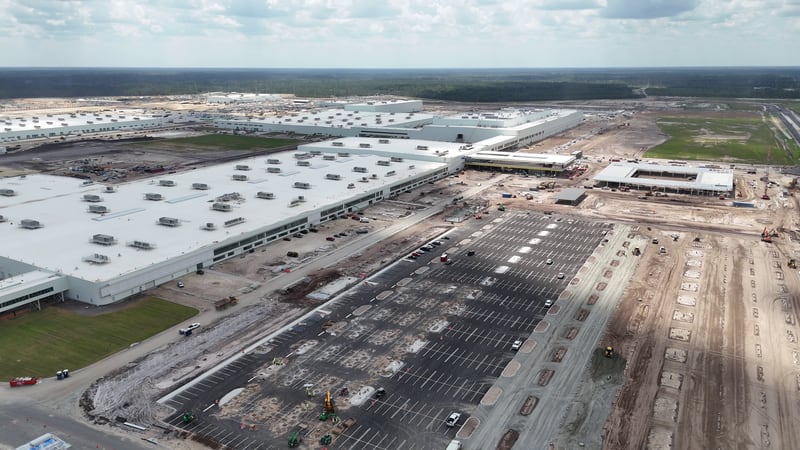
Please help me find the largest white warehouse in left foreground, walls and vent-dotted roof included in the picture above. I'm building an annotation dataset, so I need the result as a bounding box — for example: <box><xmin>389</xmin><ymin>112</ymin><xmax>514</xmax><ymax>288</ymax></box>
<box><xmin>0</xmin><ymin>138</ymin><xmax>477</xmax><ymax>312</ymax></box>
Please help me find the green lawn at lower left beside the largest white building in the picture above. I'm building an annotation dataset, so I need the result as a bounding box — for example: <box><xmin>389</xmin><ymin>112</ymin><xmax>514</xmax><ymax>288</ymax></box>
<box><xmin>0</xmin><ymin>297</ymin><xmax>197</xmax><ymax>380</ymax></box>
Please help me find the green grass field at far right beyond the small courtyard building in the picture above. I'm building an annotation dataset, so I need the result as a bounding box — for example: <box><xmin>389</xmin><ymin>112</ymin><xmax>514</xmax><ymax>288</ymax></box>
<box><xmin>644</xmin><ymin>117</ymin><xmax>796</xmax><ymax>165</ymax></box>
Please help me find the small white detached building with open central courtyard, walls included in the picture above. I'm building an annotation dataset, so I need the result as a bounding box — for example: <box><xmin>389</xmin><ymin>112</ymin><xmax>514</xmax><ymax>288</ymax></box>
<box><xmin>594</xmin><ymin>162</ymin><xmax>734</xmax><ymax>197</ymax></box>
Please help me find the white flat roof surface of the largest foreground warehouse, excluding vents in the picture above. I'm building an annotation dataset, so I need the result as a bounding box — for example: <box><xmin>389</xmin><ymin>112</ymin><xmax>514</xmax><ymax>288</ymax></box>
<box><xmin>0</xmin><ymin>149</ymin><xmax>443</xmax><ymax>281</ymax></box>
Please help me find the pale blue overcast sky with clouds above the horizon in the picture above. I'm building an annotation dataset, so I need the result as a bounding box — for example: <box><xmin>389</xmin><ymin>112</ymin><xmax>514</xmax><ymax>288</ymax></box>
<box><xmin>0</xmin><ymin>0</ymin><xmax>800</xmax><ymax>68</ymax></box>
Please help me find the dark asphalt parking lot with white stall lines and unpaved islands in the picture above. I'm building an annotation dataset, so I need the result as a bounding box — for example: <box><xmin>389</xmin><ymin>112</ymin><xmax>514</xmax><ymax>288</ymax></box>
<box><xmin>161</xmin><ymin>212</ymin><xmax>609</xmax><ymax>450</ymax></box>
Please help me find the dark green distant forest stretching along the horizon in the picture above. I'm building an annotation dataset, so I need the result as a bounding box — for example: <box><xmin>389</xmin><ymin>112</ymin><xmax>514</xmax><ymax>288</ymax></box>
<box><xmin>0</xmin><ymin>67</ymin><xmax>800</xmax><ymax>102</ymax></box>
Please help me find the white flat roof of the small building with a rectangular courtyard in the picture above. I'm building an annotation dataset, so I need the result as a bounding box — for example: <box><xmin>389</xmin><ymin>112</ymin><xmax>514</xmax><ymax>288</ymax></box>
<box><xmin>594</xmin><ymin>163</ymin><xmax>733</xmax><ymax>191</ymax></box>
